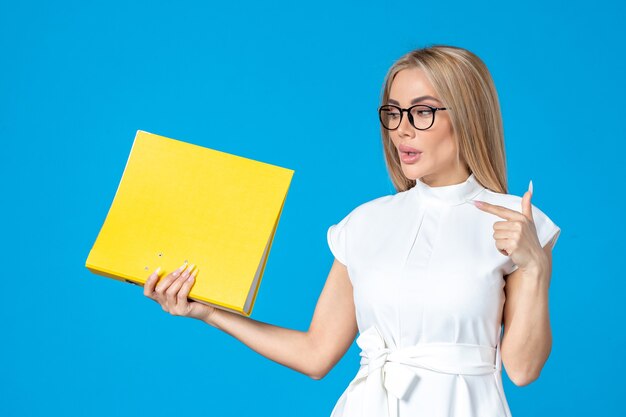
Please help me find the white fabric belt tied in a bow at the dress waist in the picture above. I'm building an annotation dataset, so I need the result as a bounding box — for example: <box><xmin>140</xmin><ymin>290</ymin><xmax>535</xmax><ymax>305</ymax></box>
<box><xmin>346</xmin><ymin>327</ymin><xmax>500</xmax><ymax>417</ymax></box>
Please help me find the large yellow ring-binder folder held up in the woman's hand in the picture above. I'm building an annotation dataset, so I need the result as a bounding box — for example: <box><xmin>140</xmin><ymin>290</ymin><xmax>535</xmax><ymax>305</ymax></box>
<box><xmin>85</xmin><ymin>130</ymin><xmax>294</xmax><ymax>316</ymax></box>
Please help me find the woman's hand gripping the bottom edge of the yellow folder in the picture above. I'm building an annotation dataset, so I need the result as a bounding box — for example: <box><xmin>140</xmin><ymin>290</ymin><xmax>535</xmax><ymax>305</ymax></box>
<box><xmin>143</xmin><ymin>262</ymin><xmax>215</xmax><ymax>322</ymax></box>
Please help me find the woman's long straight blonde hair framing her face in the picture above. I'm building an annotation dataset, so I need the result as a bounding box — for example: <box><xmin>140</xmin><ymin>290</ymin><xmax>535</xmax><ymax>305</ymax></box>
<box><xmin>380</xmin><ymin>45</ymin><xmax>507</xmax><ymax>193</ymax></box>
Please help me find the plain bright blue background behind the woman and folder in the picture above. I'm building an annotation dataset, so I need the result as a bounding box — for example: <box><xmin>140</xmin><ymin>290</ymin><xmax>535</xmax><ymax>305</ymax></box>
<box><xmin>0</xmin><ymin>0</ymin><xmax>626</xmax><ymax>417</ymax></box>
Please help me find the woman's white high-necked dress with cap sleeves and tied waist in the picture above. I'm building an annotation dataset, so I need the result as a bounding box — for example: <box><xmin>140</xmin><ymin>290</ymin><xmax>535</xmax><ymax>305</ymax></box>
<box><xmin>327</xmin><ymin>174</ymin><xmax>560</xmax><ymax>417</ymax></box>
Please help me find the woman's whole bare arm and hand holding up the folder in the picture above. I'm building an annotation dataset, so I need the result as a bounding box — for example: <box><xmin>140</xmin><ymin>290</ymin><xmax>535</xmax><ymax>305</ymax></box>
<box><xmin>144</xmin><ymin>260</ymin><xmax>357</xmax><ymax>379</ymax></box>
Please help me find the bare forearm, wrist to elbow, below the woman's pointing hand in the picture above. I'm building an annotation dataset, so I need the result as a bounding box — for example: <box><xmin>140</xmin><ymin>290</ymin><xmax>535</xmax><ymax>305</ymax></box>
<box><xmin>501</xmin><ymin>244</ymin><xmax>552</xmax><ymax>386</ymax></box>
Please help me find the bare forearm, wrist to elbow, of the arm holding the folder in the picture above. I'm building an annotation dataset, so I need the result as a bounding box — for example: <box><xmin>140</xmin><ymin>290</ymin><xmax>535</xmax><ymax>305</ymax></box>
<box><xmin>203</xmin><ymin>309</ymin><xmax>319</xmax><ymax>379</ymax></box>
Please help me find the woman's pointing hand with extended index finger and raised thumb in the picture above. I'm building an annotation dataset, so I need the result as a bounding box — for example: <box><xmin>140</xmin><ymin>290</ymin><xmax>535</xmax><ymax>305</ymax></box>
<box><xmin>474</xmin><ymin>183</ymin><xmax>546</xmax><ymax>270</ymax></box>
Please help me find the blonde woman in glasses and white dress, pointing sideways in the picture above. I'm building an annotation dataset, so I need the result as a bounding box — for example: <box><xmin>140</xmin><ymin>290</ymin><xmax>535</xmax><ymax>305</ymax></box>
<box><xmin>144</xmin><ymin>45</ymin><xmax>560</xmax><ymax>417</ymax></box>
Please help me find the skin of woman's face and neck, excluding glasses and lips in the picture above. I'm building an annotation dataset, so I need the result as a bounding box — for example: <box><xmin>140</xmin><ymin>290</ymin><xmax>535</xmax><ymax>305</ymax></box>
<box><xmin>386</xmin><ymin>68</ymin><xmax>470</xmax><ymax>186</ymax></box>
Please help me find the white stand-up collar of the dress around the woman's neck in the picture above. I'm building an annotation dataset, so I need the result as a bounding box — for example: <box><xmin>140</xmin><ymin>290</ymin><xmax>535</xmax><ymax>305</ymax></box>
<box><xmin>410</xmin><ymin>173</ymin><xmax>485</xmax><ymax>206</ymax></box>
